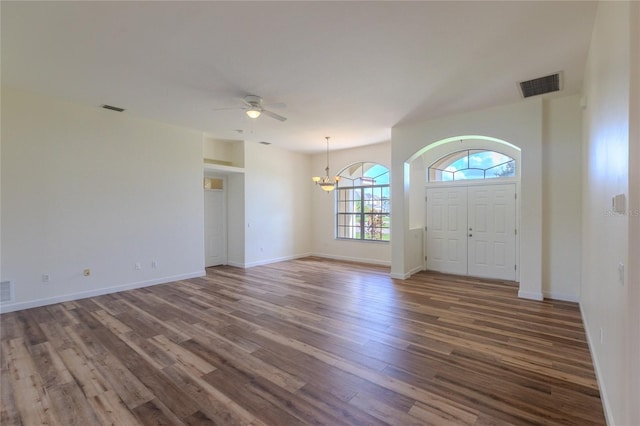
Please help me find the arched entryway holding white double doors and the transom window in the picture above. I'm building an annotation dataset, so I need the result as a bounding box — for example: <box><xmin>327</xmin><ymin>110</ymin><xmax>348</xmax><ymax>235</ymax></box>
<box><xmin>416</xmin><ymin>136</ymin><xmax>521</xmax><ymax>281</ymax></box>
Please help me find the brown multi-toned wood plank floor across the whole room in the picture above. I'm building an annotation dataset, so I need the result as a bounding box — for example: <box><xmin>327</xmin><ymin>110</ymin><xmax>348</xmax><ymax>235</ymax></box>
<box><xmin>0</xmin><ymin>258</ymin><xmax>605</xmax><ymax>426</ymax></box>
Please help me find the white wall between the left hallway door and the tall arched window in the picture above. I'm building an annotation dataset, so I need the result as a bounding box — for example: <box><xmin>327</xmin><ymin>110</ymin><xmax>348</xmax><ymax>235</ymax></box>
<box><xmin>244</xmin><ymin>142</ymin><xmax>312</xmax><ymax>267</ymax></box>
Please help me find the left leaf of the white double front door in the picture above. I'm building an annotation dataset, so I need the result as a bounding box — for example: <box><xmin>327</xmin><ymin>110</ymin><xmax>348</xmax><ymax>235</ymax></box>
<box><xmin>426</xmin><ymin>187</ymin><xmax>467</xmax><ymax>275</ymax></box>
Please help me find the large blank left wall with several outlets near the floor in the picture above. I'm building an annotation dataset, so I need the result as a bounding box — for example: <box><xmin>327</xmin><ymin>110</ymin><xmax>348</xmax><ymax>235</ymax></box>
<box><xmin>1</xmin><ymin>88</ymin><xmax>204</xmax><ymax>311</ymax></box>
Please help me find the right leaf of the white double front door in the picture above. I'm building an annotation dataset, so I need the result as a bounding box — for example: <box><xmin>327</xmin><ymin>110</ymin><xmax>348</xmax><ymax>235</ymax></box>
<box><xmin>467</xmin><ymin>184</ymin><xmax>516</xmax><ymax>281</ymax></box>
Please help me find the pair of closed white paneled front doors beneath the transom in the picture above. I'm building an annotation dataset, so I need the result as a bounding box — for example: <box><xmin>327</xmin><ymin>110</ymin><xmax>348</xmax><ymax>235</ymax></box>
<box><xmin>425</xmin><ymin>184</ymin><xmax>516</xmax><ymax>281</ymax></box>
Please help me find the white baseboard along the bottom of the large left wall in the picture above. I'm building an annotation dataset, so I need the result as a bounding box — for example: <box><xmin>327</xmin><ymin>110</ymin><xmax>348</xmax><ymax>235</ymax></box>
<box><xmin>0</xmin><ymin>270</ymin><xmax>206</xmax><ymax>314</ymax></box>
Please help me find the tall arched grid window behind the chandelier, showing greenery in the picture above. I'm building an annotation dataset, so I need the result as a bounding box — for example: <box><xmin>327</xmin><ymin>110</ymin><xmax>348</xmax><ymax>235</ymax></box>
<box><xmin>336</xmin><ymin>163</ymin><xmax>391</xmax><ymax>241</ymax></box>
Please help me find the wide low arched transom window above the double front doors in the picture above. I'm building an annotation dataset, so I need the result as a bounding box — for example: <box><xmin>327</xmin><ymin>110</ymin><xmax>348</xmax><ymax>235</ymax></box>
<box><xmin>427</xmin><ymin>149</ymin><xmax>516</xmax><ymax>182</ymax></box>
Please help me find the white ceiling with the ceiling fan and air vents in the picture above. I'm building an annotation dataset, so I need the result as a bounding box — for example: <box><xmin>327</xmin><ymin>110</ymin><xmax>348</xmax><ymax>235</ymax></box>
<box><xmin>0</xmin><ymin>1</ymin><xmax>597</xmax><ymax>152</ymax></box>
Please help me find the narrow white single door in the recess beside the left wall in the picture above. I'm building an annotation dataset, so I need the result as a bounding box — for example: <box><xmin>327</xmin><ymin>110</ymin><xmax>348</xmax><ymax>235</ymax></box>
<box><xmin>204</xmin><ymin>189</ymin><xmax>227</xmax><ymax>267</ymax></box>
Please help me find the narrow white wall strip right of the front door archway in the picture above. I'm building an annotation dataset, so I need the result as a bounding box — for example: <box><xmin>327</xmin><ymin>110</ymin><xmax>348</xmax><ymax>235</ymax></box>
<box><xmin>542</xmin><ymin>95</ymin><xmax>582</xmax><ymax>302</ymax></box>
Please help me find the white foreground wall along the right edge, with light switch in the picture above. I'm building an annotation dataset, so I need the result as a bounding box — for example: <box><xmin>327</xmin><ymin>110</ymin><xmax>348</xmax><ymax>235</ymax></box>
<box><xmin>580</xmin><ymin>2</ymin><xmax>640</xmax><ymax>425</ymax></box>
